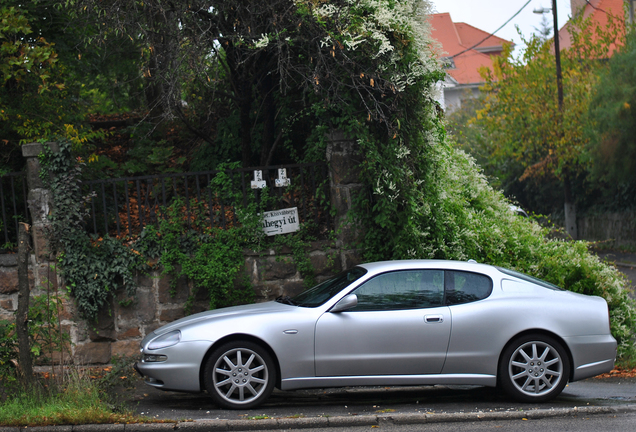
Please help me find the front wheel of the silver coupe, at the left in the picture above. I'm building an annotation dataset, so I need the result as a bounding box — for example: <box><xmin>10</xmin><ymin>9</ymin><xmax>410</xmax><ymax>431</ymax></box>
<box><xmin>203</xmin><ymin>341</ymin><xmax>276</xmax><ymax>409</ymax></box>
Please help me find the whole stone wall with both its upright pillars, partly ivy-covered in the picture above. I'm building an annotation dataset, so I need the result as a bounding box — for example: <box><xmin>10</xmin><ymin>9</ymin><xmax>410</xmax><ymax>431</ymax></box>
<box><xmin>0</xmin><ymin>132</ymin><xmax>363</xmax><ymax>364</ymax></box>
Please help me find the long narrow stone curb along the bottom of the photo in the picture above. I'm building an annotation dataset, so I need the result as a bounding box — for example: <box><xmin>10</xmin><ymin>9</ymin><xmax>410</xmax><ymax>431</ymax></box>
<box><xmin>0</xmin><ymin>404</ymin><xmax>636</xmax><ymax>432</ymax></box>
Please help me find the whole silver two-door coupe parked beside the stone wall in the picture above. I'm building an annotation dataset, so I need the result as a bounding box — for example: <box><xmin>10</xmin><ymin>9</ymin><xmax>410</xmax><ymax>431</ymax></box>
<box><xmin>136</xmin><ymin>260</ymin><xmax>616</xmax><ymax>408</ymax></box>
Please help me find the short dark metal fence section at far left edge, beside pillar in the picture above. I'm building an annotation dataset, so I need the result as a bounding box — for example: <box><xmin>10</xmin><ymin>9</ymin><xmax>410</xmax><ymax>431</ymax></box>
<box><xmin>0</xmin><ymin>172</ymin><xmax>31</xmax><ymax>249</ymax></box>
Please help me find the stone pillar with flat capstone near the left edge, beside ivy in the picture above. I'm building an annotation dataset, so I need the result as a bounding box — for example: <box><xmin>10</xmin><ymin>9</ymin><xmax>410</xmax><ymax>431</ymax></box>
<box><xmin>22</xmin><ymin>142</ymin><xmax>60</xmax><ymax>262</ymax></box>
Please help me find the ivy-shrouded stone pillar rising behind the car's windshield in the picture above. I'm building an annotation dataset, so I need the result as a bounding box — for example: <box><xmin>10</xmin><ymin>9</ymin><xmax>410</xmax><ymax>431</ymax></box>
<box><xmin>327</xmin><ymin>131</ymin><xmax>366</xmax><ymax>268</ymax></box>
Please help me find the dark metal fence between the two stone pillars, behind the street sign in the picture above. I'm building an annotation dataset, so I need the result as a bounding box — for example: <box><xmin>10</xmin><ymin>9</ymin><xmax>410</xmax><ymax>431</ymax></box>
<box><xmin>82</xmin><ymin>163</ymin><xmax>331</xmax><ymax>237</ymax></box>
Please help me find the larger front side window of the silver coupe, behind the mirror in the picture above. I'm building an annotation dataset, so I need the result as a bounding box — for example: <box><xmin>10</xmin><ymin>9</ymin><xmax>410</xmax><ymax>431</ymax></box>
<box><xmin>350</xmin><ymin>270</ymin><xmax>444</xmax><ymax>312</ymax></box>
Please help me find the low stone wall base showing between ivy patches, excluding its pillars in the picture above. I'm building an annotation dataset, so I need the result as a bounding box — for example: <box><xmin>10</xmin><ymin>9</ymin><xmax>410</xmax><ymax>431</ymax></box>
<box><xmin>0</xmin><ymin>242</ymin><xmax>357</xmax><ymax>364</ymax></box>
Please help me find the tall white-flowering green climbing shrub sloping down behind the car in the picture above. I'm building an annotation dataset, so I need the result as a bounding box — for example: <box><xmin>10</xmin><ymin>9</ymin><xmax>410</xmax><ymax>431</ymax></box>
<box><xmin>295</xmin><ymin>0</ymin><xmax>636</xmax><ymax>359</ymax></box>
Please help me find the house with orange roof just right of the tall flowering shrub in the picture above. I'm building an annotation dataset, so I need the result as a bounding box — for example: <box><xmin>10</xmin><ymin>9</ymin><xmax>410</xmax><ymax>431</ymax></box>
<box><xmin>429</xmin><ymin>13</ymin><xmax>512</xmax><ymax>112</ymax></box>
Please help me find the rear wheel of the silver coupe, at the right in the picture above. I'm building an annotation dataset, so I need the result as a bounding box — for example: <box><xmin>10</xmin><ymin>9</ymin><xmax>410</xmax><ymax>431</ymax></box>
<box><xmin>498</xmin><ymin>334</ymin><xmax>570</xmax><ymax>402</ymax></box>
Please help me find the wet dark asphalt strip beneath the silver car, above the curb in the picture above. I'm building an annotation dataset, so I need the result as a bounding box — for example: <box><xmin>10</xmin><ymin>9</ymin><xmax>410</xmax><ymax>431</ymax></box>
<box><xmin>129</xmin><ymin>378</ymin><xmax>636</xmax><ymax>420</ymax></box>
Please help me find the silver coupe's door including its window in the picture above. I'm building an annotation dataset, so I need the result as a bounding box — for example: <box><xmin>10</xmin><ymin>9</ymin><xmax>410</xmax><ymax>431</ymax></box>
<box><xmin>315</xmin><ymin>270</ymin><xmax>451</xmax><ymax>376</ymax></box>
